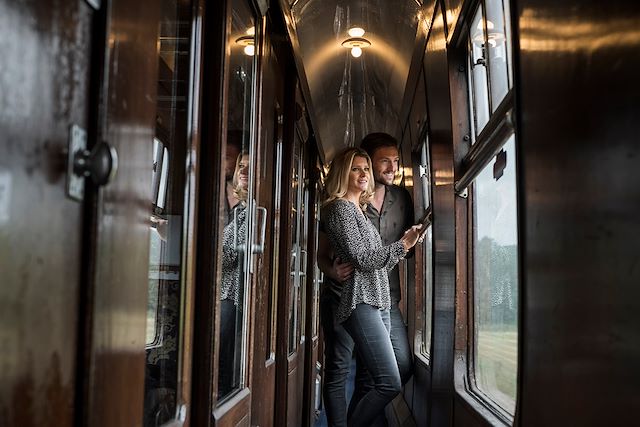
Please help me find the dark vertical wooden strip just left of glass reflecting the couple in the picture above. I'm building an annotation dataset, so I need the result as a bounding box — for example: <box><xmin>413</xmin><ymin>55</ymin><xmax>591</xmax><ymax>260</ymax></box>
<box><xmin>191</xmin><ymin>0</ymin><xmax>227</xmax><ymax>427</ymax></box>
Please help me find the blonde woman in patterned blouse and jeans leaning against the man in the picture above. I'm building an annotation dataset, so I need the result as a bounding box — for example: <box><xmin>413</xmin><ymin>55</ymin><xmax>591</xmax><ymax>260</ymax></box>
<box><xmin>323</xmin><ymin>148</ymin><xmax>420</xmax><ymax>427</ymax></box>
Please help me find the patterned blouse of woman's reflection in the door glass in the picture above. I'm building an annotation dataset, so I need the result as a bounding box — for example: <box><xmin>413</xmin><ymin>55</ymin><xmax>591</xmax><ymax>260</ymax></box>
<box><xmin>220</xmin><ymin>205</ymin><xmax>247</xmax><ymax>306</ymax></box>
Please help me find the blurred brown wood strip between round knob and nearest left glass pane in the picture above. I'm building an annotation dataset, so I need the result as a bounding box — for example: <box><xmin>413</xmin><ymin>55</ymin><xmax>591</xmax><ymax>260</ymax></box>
<box><xmin>86</xmin><ymin>0</ymin><xmax>159</xmax><ymax>426</ymax></box>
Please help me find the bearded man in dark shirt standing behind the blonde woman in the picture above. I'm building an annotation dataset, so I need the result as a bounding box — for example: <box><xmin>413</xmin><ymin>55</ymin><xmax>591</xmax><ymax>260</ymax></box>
<box><xmin>318</xmin><ymin>133</ymin><xmax>413</xmax><ymax>425</ymax></box>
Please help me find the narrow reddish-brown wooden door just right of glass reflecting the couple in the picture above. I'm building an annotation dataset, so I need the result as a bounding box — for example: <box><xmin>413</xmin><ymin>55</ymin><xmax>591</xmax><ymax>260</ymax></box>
<box><xmin>251</xmin><ymin>20</ymin><xmax>284</xmax><ymax>427</ymax></box>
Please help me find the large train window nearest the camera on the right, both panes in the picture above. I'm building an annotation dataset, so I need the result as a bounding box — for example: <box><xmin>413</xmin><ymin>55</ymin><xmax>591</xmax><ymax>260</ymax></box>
<box><xmin>456</xmin><ymin>0</ymin><xmax>519</xmax><ymax>420</ymax></box>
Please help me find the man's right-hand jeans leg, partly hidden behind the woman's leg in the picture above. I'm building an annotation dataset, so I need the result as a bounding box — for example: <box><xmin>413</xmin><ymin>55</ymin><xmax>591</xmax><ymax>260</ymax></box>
<box><xmin>347</xmin><ymin>302</ymin><xmax>413</xmax><ymax>426</ymax></box>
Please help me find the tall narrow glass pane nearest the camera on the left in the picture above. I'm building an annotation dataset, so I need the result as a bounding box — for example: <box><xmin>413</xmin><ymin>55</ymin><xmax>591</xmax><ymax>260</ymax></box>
<box><xmin>143</xmin><ymin>0</ymin><xmax>191</xmax><ymax>426</ymax></box>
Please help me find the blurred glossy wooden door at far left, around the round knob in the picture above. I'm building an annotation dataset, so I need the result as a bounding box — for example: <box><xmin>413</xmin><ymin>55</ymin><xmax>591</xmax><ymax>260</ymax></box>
<box><xmin>0</xmin><ymin>0</ymin><xmax>157</xmax><ymax>426</ymax></box>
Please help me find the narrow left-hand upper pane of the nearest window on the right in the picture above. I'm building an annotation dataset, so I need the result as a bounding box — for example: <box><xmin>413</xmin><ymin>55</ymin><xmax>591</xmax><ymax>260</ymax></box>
<box><xmin>469</xmin><ymin>8</ymin><xmax>489</xmax><ymax>141</ymax></box>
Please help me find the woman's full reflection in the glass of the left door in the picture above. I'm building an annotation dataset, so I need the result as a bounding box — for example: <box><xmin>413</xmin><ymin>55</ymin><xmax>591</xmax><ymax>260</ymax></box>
<box><xmin>218</xmin><ymin>153</ymin><xmax>249</xmax><ymax>398</ymax></box>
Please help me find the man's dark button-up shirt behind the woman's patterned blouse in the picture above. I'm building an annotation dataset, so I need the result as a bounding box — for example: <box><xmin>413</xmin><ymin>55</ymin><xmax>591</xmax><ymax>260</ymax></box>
<box><xmin>365</xmin><ymin>185</ymin><xmax>414</xmax><ymax>304</ymax></box>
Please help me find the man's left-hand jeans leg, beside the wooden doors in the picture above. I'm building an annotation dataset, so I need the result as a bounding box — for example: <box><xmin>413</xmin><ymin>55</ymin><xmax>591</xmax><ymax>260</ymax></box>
<box><xmin>320</xmin><ymin>291</ymin><xmax>353</xmax><ymax>427</ymax></box>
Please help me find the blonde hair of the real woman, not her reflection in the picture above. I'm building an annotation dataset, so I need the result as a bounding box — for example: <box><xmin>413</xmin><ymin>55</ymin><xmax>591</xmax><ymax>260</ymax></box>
<box><xmin>323</xmin><ymin>147</ymin><xmax>375</xmax><ymax>209</ymax></box>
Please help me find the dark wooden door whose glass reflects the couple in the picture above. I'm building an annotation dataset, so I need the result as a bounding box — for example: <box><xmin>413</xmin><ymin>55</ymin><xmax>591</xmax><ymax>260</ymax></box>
<box><xmin>192</xmin><ymin>0</ymin><xmax>262</xmax><ymax>426</ymax></box>
